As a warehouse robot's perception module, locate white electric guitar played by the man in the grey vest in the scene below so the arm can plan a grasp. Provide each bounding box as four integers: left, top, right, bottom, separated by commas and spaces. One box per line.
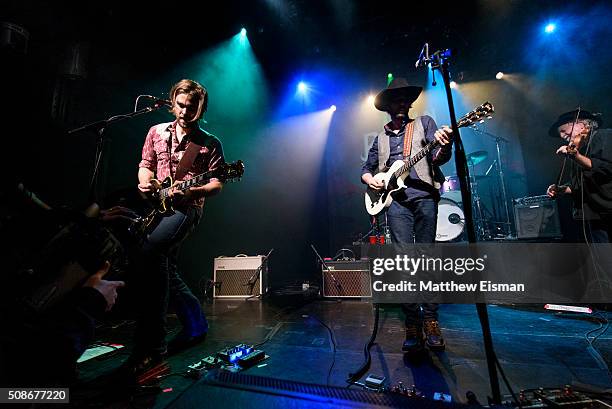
365, 102, 495, 216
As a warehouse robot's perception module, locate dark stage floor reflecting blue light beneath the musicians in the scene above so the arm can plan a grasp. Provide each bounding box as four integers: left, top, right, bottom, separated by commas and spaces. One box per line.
72, 299, 612, 408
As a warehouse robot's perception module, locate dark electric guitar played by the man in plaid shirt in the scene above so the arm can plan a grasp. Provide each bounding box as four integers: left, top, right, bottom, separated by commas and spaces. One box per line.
142, 160, 244, 227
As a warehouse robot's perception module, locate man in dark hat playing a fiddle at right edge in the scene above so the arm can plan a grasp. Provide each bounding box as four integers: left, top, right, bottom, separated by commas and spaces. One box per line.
546, 110, 612, 243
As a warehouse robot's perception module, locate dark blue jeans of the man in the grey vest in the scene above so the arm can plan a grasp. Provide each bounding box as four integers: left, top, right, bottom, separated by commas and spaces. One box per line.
387, 198, 438, 326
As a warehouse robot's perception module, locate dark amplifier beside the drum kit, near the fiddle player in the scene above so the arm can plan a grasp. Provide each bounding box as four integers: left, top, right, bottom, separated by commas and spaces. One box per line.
514, 196, 562, 239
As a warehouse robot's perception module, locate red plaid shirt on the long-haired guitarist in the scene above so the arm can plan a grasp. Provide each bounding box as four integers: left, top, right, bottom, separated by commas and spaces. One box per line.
138, 122, 225, 207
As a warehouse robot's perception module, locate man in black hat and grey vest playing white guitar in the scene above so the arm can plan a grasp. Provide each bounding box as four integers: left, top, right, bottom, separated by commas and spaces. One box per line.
361, 78, 452, 352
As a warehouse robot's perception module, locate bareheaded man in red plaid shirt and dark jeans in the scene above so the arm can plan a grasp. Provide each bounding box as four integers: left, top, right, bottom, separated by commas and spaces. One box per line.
121, 79, 224, 375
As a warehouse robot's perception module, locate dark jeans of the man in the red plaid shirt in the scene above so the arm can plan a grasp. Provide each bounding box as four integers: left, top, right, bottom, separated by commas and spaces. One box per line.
135, 207, 208, 352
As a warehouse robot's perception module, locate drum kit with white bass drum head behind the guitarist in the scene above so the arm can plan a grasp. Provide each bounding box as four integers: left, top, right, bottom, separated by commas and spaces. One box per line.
436, 151, 510, 242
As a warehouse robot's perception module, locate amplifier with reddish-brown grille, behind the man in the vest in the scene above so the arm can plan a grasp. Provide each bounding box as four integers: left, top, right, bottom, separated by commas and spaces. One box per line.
321, 260, 372, 298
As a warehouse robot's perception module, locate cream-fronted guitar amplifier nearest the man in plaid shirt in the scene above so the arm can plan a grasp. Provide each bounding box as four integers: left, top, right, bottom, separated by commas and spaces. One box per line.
213, 256, 268, 298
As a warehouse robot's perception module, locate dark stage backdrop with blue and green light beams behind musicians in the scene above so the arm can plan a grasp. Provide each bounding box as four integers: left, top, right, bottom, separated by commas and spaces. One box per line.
0, 0, 612, 294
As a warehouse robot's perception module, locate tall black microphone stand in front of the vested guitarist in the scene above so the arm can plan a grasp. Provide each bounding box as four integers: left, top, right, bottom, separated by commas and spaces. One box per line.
424, 49, 501, 404
